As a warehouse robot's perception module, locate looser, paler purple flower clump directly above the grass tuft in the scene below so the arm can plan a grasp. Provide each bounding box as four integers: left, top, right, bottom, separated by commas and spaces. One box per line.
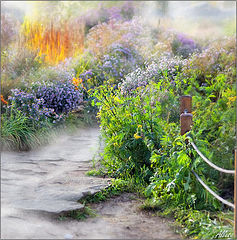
8, 89, 63, 126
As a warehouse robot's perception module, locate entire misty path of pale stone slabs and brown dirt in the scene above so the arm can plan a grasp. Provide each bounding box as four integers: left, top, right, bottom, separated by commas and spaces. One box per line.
1, 128, 180, 239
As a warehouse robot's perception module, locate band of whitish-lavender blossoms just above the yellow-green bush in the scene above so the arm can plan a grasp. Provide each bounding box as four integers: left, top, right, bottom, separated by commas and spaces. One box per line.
120, 55, 187, 93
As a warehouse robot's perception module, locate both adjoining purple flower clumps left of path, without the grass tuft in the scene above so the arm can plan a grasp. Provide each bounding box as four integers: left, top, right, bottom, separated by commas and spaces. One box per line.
8, 80, 83, 126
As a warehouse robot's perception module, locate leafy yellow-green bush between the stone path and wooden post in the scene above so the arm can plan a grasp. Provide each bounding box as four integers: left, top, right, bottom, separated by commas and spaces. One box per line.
92, 81, 177, 182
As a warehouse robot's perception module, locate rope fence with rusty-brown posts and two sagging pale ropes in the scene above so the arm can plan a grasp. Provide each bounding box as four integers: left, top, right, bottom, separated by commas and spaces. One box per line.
180, 96, 237, 238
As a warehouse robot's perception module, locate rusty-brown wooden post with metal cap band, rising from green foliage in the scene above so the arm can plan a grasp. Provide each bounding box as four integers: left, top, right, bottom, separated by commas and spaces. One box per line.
180, 96, 193, 135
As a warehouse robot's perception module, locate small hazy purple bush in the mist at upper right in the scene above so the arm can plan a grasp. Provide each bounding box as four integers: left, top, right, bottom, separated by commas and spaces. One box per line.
171, 34, 201, 58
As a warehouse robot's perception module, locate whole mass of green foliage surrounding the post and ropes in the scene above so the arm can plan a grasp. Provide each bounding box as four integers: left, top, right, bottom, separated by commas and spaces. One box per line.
90, 37, 236, 238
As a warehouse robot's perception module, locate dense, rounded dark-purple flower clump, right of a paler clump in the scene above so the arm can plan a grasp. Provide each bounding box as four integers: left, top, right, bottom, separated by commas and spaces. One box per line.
33, 80, 83, 114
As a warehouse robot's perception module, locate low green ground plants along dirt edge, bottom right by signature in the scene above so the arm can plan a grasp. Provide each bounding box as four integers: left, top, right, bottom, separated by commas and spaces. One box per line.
140, 198, 233, 239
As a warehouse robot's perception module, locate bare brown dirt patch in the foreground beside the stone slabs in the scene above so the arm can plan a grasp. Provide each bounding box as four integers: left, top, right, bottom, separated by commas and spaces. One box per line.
80, 193, 180, 239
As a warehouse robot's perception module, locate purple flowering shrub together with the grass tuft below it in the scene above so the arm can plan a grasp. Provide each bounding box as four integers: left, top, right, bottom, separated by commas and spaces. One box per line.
1, 69, 83, 150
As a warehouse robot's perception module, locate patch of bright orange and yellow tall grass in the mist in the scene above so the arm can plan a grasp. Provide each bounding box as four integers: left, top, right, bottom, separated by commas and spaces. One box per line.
21, 18, 84, 64
